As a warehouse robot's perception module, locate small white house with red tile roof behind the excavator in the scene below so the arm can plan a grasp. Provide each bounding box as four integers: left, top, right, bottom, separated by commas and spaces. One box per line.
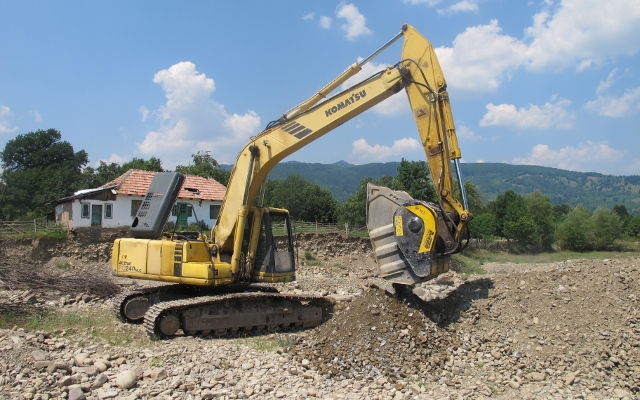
55, 169, 226, 229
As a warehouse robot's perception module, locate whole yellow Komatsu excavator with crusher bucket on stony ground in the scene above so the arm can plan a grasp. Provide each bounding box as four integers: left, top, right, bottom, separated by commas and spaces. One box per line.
112, 25, 472, 338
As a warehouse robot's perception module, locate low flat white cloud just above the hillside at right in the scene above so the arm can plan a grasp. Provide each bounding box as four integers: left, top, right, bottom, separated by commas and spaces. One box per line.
512, 141, 624, 171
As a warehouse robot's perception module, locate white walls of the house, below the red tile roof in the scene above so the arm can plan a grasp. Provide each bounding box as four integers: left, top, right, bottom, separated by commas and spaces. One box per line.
56, 195, 222, 229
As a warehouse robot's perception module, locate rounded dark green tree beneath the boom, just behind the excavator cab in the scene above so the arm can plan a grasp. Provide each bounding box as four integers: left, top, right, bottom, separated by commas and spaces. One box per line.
264, 175, 337, 222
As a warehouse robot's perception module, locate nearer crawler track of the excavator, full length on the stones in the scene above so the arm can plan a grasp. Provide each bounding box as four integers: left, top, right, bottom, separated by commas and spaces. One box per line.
144, 293, 333, 339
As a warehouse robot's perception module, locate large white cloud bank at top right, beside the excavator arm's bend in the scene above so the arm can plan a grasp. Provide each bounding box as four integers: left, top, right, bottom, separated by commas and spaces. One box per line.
430, 0, 640, 92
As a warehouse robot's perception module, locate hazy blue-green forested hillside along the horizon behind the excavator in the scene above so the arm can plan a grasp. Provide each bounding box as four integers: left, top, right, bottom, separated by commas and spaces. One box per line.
226, 161, 640, 214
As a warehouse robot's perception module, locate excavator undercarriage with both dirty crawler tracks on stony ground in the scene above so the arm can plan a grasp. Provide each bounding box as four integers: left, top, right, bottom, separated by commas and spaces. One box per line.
113, 284, 333, 339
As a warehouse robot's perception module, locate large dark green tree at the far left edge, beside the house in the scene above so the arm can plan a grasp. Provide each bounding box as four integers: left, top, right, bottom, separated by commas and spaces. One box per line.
0, 129, 88, 219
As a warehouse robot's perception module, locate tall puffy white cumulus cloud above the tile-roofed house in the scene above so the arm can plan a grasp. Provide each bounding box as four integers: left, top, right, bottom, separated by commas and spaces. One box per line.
138, 61, 260, 168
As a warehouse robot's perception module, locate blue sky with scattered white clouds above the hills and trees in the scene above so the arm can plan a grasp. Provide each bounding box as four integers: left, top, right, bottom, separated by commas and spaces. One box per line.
0, 0, 640, 175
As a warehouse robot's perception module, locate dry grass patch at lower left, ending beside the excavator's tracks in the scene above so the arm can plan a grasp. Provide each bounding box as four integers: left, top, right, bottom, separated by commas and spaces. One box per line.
0, 309, 151, 346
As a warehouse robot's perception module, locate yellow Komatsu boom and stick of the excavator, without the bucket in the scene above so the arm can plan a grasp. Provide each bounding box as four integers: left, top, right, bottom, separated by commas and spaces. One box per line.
212, 25, 471, 255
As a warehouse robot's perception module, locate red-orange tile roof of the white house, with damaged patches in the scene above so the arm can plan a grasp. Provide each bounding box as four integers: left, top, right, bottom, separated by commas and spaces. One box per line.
101, 169, 227, 200
